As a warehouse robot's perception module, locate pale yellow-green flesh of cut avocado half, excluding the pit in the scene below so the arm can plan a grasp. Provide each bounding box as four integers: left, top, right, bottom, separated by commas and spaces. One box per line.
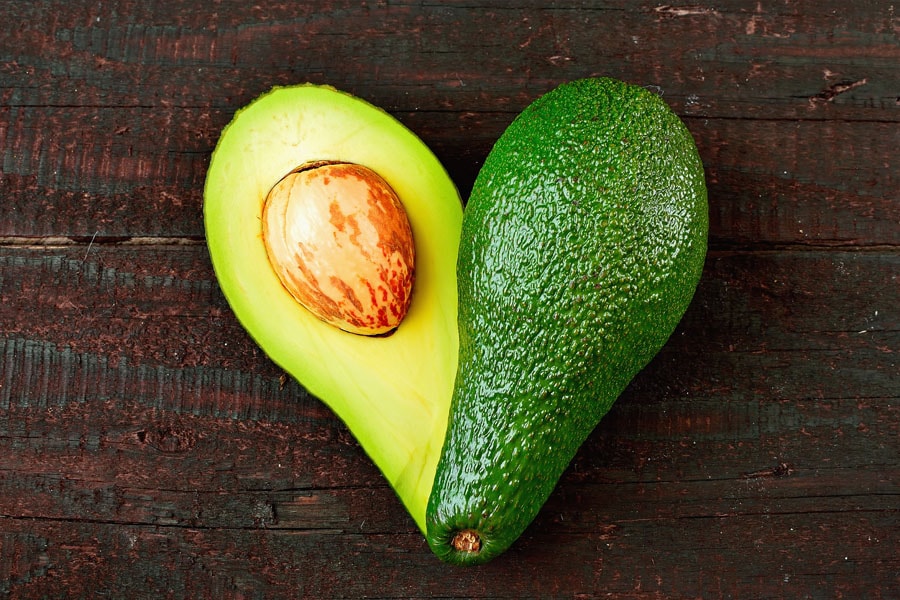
203, 84, 462, 531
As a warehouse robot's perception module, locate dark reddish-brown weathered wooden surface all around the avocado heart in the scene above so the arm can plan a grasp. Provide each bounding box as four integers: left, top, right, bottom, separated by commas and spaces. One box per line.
0, 0, 900, 599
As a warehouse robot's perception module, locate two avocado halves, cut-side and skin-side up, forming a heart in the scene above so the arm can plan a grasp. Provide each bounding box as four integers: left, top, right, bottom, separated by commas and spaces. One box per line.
204, 78, 708, 564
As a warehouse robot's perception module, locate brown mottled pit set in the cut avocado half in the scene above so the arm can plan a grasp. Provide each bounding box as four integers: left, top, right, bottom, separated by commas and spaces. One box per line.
262, 161, 415, 336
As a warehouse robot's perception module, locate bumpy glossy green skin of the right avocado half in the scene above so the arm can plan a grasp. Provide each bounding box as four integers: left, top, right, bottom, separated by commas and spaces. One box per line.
426, 79, 708, 564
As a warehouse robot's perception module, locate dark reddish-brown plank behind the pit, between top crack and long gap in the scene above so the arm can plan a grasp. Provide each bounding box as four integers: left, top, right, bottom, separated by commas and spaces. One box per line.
0, 108, 900, 247
